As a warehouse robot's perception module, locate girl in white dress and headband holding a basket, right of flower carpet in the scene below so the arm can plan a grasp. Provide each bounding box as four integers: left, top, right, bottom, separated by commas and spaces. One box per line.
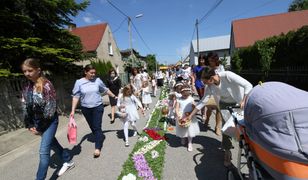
175, 85, 200, 151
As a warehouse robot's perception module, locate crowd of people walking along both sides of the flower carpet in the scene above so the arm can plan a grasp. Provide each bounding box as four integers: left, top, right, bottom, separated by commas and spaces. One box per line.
22, 53, 252, 179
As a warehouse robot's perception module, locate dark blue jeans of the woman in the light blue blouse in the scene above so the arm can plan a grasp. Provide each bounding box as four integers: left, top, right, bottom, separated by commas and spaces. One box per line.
81, 104, 104, 149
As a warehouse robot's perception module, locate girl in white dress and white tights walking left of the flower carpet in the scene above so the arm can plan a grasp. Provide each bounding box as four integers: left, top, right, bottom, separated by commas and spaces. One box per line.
117, 86, 144, 147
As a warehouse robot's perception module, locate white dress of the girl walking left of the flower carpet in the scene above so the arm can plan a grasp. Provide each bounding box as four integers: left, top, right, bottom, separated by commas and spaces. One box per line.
117, 93, 142, 122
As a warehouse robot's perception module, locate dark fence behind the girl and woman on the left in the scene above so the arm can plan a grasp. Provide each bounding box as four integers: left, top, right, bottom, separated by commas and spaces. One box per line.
0, 73, 129, 135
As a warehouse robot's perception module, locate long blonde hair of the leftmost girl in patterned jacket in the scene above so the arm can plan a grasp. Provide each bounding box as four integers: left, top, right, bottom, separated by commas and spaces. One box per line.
22, 58, 46, 93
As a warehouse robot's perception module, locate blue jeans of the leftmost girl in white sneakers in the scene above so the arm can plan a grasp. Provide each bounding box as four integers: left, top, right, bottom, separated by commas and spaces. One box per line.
36, 116, 71, 180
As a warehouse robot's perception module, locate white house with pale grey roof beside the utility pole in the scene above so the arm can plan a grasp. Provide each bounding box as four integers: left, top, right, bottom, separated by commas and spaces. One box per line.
189, 35, 230, 65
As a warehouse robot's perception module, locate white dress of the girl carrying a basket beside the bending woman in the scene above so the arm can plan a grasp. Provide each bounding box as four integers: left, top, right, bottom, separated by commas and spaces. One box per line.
176, 96, 200, 138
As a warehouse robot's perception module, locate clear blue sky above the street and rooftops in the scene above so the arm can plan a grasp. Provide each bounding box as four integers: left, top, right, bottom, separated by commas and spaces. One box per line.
72, 0, 292, 64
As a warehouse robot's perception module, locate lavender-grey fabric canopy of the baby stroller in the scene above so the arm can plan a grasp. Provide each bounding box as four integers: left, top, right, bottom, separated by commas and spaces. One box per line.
244, 82, 308, 163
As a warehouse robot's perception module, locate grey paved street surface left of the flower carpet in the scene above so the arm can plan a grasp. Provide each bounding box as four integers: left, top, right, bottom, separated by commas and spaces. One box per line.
0, 93, 158, 180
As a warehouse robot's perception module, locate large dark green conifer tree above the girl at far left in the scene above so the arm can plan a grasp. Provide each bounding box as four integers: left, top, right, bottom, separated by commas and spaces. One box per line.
0, 0, 89, 75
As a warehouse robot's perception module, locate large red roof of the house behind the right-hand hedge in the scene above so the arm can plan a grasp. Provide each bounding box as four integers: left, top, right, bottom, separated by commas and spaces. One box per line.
230, 10, 308, 54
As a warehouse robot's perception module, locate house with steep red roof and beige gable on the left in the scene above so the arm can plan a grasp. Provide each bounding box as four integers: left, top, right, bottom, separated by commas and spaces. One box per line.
69, 23, 124, 73
